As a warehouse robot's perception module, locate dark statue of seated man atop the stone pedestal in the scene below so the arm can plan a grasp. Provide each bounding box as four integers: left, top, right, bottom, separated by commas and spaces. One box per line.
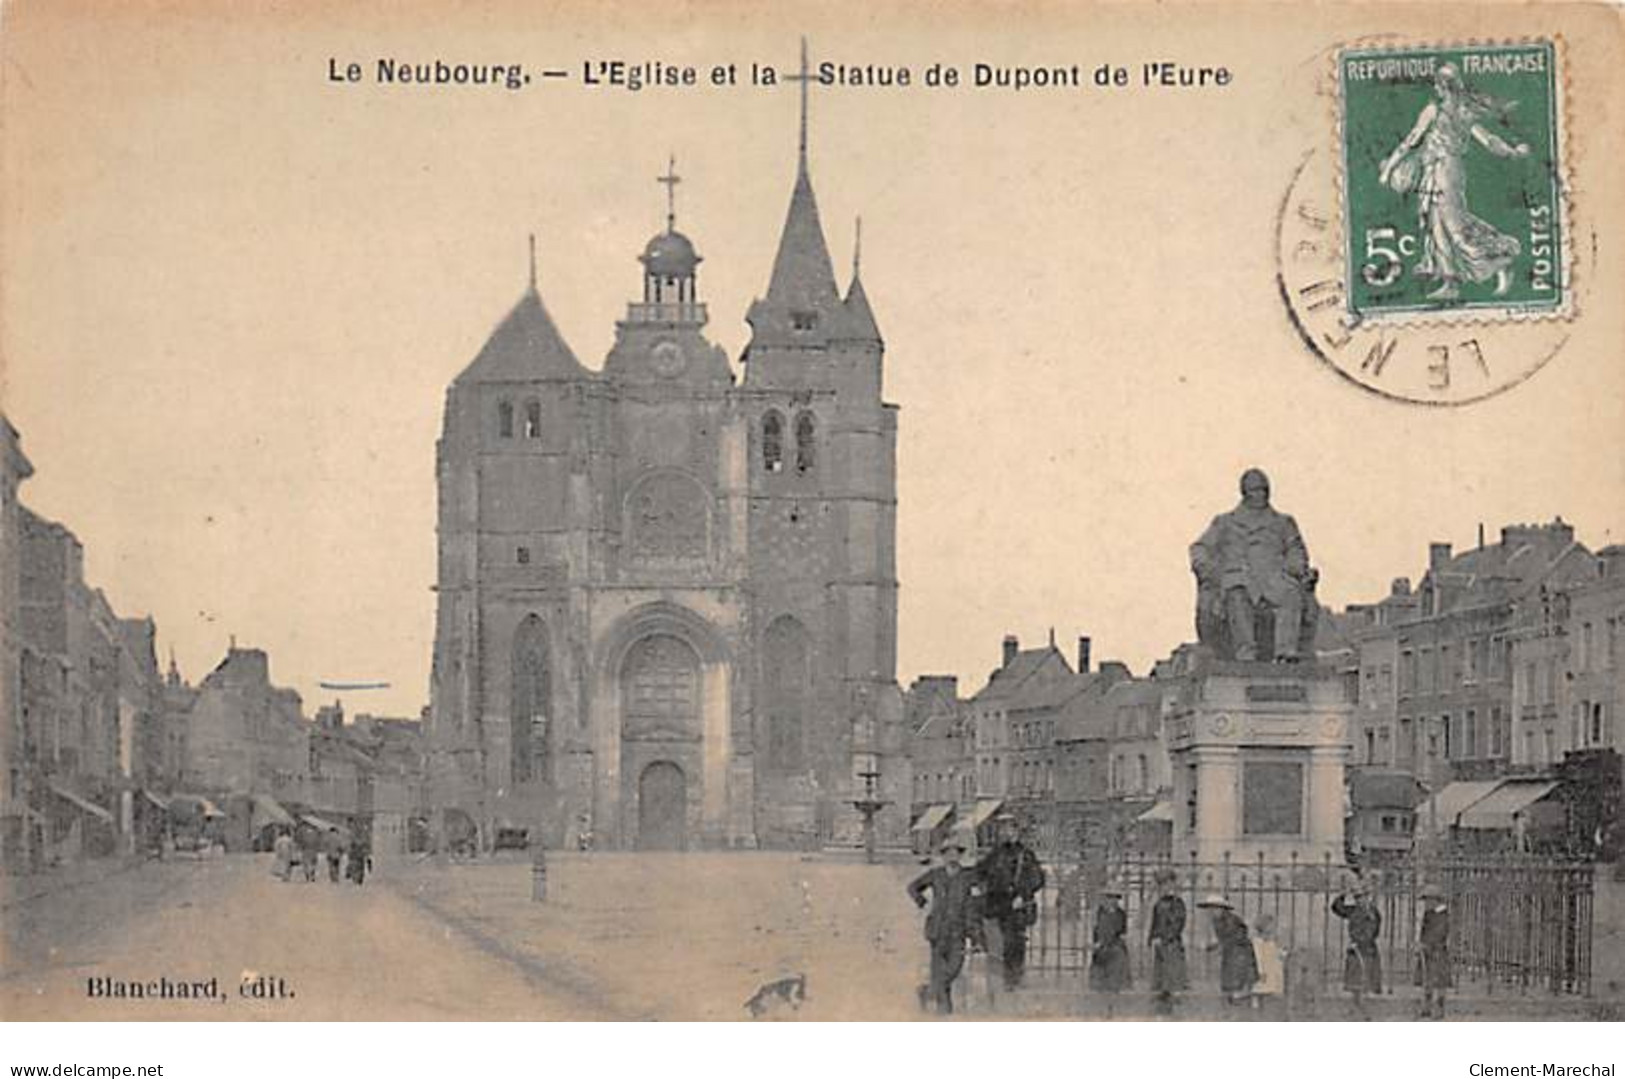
1191, 468, 1320, 661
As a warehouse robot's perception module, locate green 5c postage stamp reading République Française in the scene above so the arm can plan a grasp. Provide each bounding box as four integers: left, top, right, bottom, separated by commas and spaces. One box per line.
1337, 41, 1570, 322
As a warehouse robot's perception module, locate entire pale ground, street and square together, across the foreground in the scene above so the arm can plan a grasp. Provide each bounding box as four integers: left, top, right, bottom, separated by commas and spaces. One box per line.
0, 852, 1622, 1021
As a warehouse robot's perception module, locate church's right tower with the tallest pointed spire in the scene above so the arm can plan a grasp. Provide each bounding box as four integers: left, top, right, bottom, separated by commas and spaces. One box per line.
739, 42, 908, 845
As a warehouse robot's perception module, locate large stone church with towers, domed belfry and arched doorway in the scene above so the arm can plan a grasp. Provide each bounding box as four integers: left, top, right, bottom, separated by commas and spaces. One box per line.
429, 81, 908, 850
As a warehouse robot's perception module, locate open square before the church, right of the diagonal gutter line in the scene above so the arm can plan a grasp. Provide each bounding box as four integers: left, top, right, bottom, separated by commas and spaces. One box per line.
380, 852, 1622, 1022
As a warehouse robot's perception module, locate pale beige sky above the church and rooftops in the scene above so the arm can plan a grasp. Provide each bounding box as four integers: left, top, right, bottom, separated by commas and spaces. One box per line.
0, 3, 1625, 715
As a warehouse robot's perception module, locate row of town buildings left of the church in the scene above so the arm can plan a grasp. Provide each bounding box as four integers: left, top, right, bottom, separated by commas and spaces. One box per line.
0, 418, 427, 873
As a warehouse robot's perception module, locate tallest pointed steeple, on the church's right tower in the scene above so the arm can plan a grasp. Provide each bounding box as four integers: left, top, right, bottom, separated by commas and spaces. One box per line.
748, 39, 840, 333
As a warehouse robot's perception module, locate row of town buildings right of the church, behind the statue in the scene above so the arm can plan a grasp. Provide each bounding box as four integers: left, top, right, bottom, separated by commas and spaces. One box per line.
905, 520, 1625, 853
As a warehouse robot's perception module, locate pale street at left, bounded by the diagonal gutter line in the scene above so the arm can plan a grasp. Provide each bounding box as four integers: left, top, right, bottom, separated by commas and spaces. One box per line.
0, 856, 609, 1021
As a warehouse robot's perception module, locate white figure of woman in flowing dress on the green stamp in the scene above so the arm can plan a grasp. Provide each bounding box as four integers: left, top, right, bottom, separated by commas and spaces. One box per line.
1376, 63, 1529, 299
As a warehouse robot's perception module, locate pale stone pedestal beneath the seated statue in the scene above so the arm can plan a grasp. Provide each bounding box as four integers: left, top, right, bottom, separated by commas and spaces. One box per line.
1165, 660, 1354, 863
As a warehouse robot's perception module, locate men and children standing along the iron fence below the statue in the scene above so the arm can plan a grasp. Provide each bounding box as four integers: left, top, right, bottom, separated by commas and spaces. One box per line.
908, 819, 1451, 1019
